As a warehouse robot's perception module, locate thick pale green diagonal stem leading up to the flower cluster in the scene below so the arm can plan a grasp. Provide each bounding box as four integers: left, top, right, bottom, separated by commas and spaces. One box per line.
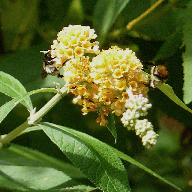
0, 88, 66, 145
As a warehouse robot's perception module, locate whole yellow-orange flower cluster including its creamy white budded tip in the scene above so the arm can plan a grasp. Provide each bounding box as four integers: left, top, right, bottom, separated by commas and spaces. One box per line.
45, 25, 158, 147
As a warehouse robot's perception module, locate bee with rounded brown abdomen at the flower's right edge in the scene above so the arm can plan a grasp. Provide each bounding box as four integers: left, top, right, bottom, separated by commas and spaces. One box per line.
150, 65, 168, 88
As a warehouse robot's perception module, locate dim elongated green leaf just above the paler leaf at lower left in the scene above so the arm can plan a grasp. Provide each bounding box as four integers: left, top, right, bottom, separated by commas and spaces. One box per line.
0, 144, 85, 178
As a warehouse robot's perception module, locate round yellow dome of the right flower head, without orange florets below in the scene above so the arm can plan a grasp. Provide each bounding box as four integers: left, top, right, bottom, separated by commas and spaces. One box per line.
91, 46, 147, 92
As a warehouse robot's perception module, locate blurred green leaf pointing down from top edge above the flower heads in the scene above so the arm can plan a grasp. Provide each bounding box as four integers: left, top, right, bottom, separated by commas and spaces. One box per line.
93, 0, 129, 43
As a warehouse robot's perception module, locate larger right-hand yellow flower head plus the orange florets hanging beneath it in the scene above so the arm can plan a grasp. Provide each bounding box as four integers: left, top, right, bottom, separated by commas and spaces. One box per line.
90, 46, 148, 119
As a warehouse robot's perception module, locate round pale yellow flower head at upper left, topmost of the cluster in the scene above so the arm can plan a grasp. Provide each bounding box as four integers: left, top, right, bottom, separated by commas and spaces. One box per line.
51, 25, 99, 69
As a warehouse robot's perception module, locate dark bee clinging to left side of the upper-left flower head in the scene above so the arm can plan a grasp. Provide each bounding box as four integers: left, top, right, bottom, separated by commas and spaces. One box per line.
41, 50, 59, 78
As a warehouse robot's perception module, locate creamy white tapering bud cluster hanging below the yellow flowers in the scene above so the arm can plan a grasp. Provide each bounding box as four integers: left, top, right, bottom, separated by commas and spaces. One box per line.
121, 88, 158, 148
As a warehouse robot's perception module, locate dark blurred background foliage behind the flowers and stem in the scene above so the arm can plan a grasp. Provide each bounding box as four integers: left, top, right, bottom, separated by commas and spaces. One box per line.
0, 0, 192, 192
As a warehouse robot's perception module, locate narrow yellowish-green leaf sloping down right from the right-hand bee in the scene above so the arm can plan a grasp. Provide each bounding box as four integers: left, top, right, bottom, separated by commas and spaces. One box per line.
158, 83, 192, 113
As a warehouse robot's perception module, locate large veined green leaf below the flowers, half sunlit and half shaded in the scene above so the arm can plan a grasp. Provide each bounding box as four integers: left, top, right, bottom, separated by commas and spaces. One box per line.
39, 123, 130, 192
